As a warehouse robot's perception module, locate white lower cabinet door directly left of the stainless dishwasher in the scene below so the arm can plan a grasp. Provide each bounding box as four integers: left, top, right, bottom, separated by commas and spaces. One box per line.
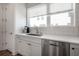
31, 43, 41, 56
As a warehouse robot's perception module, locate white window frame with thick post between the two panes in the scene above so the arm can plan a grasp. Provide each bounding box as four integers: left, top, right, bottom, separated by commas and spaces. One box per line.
26, 3, 76, 27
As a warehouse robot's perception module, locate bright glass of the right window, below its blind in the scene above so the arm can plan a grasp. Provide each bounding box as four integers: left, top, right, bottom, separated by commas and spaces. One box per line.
50, 12, 71, 26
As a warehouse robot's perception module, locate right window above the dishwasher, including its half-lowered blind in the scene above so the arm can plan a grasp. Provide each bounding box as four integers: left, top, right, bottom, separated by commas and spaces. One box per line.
49, 3, 74, 26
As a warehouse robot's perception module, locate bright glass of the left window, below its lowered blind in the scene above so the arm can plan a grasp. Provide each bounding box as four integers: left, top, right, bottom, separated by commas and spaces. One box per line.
29, 16, 47, 27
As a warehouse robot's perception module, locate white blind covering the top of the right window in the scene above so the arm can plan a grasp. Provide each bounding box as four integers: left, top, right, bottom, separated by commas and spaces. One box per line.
49, 3, 73, 13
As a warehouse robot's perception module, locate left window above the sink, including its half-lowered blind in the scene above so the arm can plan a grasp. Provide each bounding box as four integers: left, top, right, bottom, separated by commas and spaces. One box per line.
27, 4, 47, 27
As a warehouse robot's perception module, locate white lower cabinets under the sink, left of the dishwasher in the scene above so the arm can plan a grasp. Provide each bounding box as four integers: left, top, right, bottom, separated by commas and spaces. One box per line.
16, 38, 41, 56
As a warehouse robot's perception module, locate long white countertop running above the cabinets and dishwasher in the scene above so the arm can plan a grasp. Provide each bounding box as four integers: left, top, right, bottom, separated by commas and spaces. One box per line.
16, 33, 79, 44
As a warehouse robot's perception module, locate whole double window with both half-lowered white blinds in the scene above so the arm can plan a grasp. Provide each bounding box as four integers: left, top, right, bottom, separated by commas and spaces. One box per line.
27, 3, 74, 27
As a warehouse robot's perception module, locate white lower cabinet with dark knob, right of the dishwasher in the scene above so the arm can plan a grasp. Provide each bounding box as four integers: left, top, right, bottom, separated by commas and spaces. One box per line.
70, 44, 79, 56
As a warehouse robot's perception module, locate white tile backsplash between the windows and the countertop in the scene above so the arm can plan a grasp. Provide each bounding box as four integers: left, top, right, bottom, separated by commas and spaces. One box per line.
31, 26, 79, 36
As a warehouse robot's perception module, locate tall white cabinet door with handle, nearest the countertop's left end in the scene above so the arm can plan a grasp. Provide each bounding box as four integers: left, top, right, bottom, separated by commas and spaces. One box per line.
5, 4, 15, 53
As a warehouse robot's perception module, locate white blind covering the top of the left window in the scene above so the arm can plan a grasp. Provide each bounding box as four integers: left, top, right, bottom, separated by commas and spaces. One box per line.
27, 4, 47, 18
